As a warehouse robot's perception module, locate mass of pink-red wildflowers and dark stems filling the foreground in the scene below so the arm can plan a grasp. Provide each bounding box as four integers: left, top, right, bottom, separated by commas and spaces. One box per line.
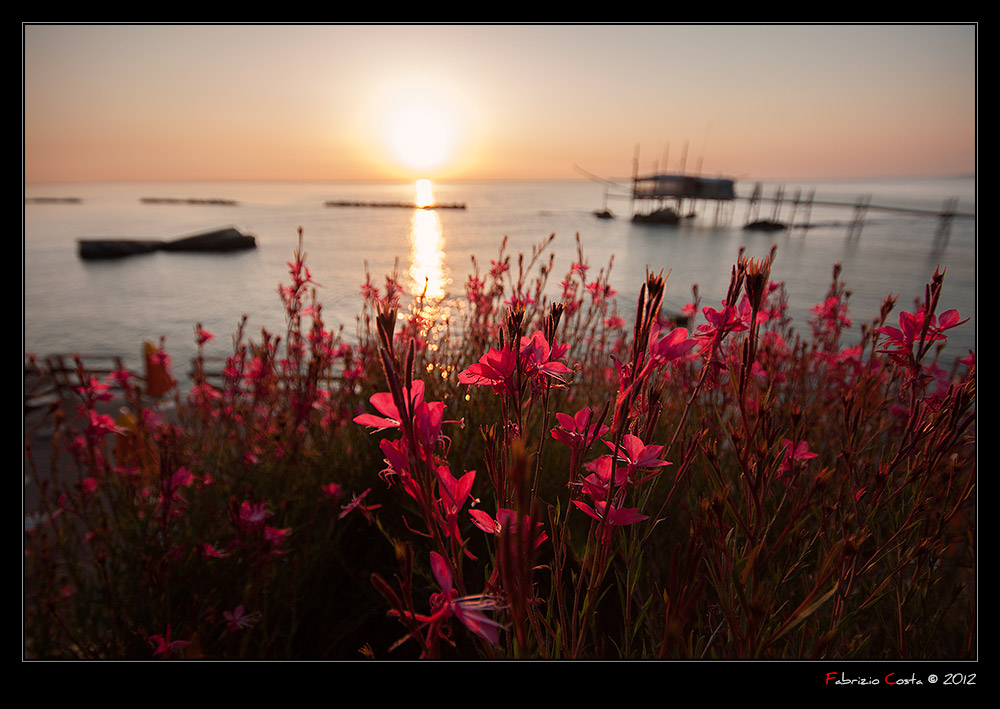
24, 231, 976, 659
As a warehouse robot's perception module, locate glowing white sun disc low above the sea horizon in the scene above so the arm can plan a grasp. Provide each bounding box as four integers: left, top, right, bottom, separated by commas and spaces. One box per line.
383, 89, 459, 171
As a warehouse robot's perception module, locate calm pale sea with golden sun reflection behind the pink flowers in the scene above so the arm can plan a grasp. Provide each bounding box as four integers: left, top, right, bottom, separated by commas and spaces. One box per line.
22, 177, 977, 373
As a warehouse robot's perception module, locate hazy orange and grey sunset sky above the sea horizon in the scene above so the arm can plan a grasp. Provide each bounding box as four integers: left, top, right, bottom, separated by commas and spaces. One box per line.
23, 24, 977, 182
